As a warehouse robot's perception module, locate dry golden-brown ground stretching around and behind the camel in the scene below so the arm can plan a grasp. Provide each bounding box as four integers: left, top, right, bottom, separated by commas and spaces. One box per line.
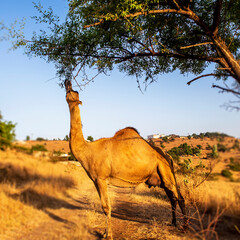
0, 137, 240, 240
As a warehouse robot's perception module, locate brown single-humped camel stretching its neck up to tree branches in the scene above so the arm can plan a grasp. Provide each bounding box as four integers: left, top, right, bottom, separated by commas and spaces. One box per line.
65, 81, 186, 239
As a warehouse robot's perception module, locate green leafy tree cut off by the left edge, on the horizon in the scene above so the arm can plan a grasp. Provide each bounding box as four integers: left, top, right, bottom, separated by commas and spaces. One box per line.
0, 114, 16, 150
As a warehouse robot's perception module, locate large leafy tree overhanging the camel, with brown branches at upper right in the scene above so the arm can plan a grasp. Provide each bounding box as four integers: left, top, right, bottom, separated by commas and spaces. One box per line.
3, 0, 240, 110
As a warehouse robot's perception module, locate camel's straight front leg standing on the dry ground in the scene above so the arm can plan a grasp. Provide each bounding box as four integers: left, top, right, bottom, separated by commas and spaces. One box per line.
95, 179, 113, 240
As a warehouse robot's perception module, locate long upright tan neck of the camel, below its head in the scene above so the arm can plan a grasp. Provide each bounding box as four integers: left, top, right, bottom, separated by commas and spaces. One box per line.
69, 102, 86, 154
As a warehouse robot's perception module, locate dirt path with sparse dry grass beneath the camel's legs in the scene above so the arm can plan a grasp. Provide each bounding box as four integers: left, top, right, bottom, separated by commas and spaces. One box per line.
15, 183, 188, 240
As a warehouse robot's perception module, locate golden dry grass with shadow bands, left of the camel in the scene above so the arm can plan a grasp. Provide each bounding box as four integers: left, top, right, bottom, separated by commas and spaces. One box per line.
0, 151, 93, 239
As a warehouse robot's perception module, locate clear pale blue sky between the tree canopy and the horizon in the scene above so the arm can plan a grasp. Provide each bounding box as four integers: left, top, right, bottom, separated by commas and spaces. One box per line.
0, 0, 240, 140
